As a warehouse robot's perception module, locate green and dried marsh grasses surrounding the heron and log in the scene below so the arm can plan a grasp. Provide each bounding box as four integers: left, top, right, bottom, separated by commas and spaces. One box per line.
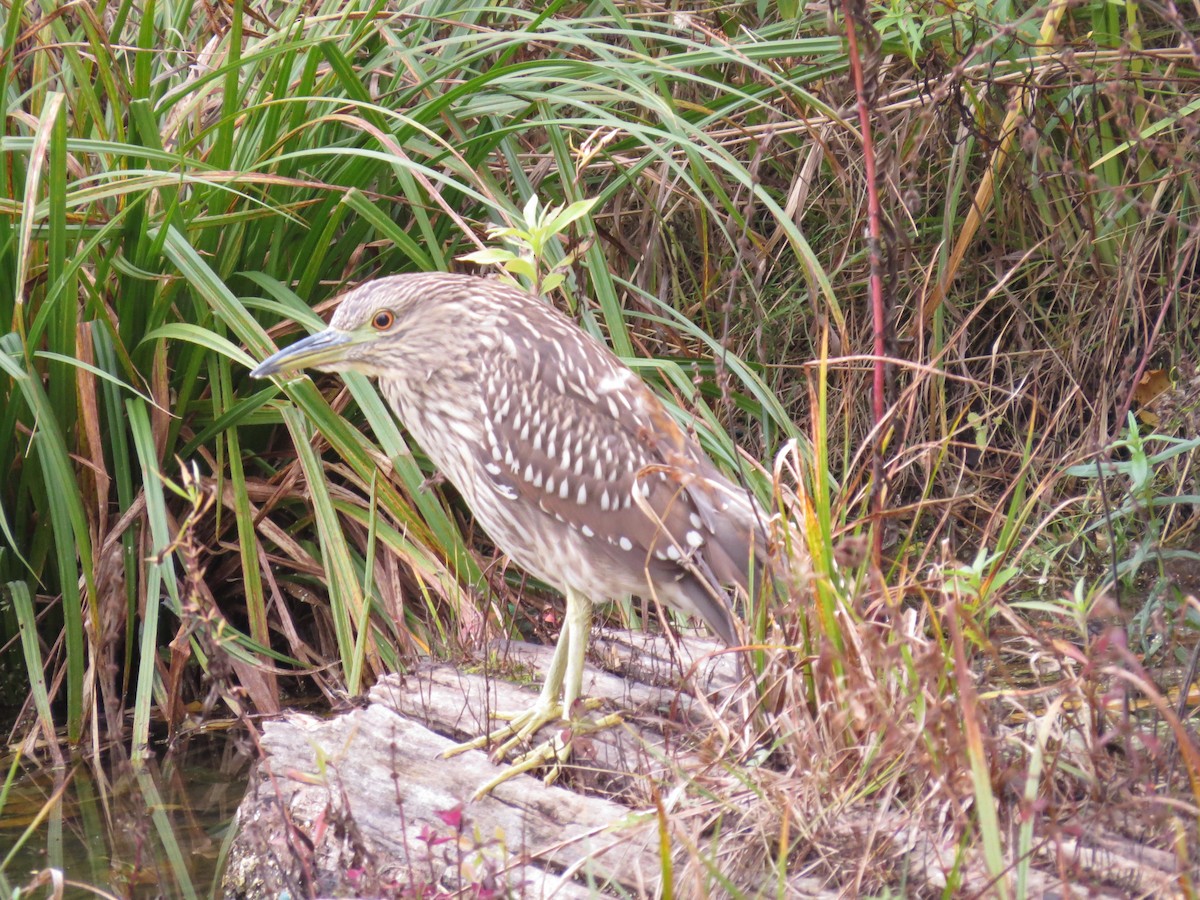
0, 0, 1200, 896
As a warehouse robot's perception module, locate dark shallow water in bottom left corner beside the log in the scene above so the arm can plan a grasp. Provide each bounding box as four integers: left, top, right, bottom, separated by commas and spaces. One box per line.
0, 726, 251, 900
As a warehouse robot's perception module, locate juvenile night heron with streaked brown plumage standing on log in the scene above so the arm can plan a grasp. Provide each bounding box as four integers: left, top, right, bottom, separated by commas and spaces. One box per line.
252, 274, 764, 791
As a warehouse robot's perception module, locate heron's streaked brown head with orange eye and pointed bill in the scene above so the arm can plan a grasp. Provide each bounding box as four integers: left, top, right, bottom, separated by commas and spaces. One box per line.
251, 274, 487, 378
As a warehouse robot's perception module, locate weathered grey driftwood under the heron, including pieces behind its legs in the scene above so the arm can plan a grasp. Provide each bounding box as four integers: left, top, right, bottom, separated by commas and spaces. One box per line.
224, 637, 777, 898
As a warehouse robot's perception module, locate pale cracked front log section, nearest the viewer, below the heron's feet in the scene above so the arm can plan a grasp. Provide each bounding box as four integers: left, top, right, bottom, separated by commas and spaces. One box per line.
226, 703, 660, 898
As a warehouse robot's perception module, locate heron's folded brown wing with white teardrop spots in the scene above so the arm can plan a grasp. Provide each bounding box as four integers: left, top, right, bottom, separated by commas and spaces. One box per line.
480, 320, 761, 642
